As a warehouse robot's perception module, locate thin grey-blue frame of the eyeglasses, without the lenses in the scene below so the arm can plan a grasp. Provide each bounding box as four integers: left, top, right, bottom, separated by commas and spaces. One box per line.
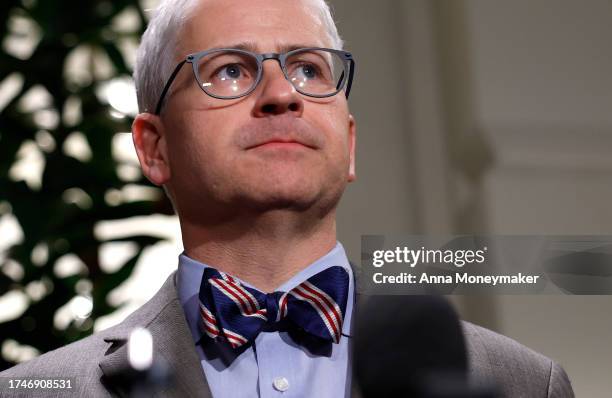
155, 47, 355, 115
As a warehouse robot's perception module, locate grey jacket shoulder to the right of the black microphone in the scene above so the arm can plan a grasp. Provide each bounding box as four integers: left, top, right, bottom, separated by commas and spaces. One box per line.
462, 321, 574, 398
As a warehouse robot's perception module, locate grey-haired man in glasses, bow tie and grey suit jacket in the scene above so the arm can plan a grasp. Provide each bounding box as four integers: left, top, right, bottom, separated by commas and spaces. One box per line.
3, 0, 572, 397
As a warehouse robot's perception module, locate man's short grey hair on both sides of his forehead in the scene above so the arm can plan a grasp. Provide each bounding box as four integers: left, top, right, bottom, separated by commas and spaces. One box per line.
134, 0, 344, 113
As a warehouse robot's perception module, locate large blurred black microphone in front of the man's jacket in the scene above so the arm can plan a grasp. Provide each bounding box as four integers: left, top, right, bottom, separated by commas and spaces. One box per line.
354, 296, 495, 398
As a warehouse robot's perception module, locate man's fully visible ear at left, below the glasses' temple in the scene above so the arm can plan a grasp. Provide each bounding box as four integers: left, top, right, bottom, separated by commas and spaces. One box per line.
132, 113, 170, 185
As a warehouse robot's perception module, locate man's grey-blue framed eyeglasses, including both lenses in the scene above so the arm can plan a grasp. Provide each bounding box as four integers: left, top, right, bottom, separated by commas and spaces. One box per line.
155, 47, 355, 115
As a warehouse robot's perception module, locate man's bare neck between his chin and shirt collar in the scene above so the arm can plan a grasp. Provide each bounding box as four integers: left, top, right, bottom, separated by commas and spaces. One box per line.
181, 210, 336, 292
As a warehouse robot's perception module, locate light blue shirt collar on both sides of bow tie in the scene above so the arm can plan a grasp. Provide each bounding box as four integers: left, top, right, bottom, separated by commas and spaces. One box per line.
177, 242, 355, 341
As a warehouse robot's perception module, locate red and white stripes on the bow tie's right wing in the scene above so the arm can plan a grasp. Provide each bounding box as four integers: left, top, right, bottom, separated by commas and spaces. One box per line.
288, 281, 342, 343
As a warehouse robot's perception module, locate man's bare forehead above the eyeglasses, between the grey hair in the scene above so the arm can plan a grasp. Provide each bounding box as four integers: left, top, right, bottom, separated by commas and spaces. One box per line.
179, 0, 331, 55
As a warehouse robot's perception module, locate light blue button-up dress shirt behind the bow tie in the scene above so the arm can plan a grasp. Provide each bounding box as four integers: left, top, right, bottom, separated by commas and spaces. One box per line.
177, 243, 355, 398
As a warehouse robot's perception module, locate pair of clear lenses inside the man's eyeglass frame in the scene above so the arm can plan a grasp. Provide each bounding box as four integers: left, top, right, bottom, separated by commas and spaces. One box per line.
196, 50, 346, 98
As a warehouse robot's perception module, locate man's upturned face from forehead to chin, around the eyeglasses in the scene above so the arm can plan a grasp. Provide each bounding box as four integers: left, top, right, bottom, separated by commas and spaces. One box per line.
154, 0, 355, 217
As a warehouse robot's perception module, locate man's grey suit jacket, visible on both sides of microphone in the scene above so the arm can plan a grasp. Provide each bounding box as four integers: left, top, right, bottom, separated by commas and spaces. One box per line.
0, 273, 574, 398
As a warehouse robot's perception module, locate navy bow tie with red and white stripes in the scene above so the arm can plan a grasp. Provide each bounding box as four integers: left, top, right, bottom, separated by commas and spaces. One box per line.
199, 266, 349, 349
